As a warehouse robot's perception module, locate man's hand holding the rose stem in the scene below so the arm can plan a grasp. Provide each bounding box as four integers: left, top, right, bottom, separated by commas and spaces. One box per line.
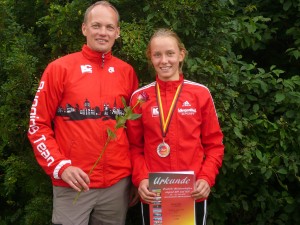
61, 166, 90, 192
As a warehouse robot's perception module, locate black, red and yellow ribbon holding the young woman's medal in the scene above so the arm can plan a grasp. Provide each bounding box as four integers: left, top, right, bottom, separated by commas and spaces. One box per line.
156, 82, 183, 137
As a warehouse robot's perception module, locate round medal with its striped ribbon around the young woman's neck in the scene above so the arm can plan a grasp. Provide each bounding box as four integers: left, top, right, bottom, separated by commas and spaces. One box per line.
156, 83, 182, 158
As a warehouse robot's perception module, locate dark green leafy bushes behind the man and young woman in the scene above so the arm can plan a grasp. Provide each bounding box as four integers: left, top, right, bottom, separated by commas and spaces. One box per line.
0, 0, 300, 225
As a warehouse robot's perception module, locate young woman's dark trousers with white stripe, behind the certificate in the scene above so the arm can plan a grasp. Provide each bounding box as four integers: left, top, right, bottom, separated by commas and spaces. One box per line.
141, 201, 207, 225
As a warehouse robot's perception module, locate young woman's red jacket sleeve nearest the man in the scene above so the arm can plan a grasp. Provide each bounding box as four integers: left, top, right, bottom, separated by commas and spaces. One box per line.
127, 93, 149, 187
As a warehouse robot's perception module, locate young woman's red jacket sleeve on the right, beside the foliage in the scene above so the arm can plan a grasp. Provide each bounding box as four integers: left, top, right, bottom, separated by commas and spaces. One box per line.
197, 90, 224, 187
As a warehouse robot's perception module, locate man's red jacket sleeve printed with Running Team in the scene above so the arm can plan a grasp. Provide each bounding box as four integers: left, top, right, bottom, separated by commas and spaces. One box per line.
27, 63, 71, 179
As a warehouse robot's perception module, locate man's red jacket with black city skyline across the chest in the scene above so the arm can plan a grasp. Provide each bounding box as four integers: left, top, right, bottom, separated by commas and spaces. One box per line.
28, 45, 138, 188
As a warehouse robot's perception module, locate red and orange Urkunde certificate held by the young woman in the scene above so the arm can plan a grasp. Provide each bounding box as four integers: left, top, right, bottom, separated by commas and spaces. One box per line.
149, 171, 196, 225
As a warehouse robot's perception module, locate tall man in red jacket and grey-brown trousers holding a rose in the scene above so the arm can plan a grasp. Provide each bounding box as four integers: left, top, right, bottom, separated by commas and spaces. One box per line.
28, 1, 138, 225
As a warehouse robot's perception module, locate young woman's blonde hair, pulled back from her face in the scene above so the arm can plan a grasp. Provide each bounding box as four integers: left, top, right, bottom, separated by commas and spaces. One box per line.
146, 28, 187, 72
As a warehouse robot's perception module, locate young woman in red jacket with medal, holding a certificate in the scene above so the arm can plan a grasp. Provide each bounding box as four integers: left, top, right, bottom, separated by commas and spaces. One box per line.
127, 29, 224, 225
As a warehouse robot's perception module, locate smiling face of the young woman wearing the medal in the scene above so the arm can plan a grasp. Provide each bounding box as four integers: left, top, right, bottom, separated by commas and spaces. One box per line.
150, 36, 185, 81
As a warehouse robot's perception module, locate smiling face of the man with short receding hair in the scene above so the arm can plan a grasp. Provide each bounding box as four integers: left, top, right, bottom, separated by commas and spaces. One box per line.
82, 5, 120, 53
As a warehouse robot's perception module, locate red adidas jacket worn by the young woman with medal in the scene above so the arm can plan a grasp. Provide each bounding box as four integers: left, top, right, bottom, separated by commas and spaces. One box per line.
127, 75, 224, 192
